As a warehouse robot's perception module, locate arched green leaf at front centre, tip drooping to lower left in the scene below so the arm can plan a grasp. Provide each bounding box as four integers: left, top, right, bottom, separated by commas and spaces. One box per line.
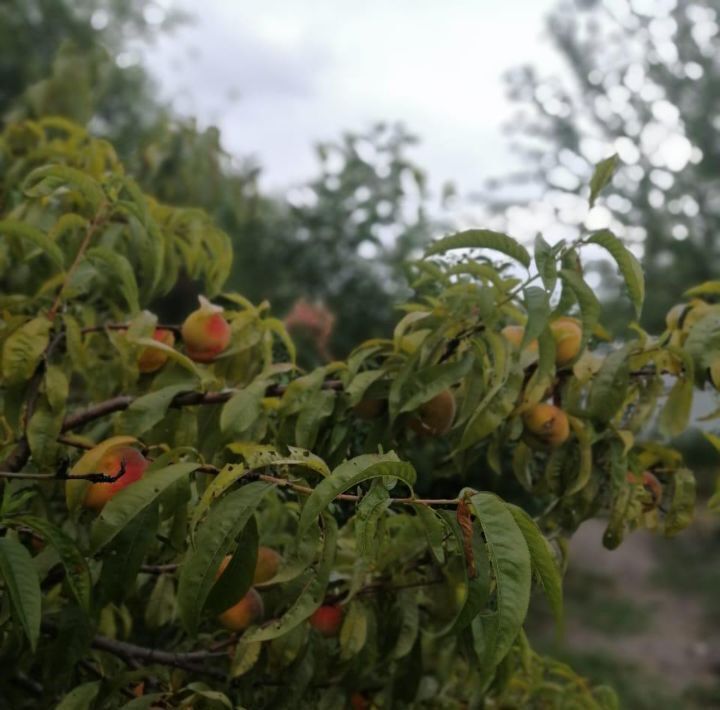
298, 452, 416, 535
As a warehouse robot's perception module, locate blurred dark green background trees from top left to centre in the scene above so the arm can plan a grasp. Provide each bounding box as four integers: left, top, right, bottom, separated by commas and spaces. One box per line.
0, 0, 433, 358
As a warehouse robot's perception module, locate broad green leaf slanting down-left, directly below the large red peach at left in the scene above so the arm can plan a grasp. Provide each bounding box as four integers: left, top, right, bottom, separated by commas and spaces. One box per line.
90, 463, 200, 552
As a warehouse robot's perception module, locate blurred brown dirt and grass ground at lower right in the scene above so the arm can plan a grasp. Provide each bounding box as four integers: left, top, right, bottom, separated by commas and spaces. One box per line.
530, 515, 720, 710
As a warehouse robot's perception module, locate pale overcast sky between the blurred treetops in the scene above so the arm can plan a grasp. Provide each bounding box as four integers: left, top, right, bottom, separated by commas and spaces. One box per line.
145, 0, 562, 192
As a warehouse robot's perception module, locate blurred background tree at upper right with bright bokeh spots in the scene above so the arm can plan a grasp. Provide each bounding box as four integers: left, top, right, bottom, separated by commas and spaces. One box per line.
485, 0, 720, 330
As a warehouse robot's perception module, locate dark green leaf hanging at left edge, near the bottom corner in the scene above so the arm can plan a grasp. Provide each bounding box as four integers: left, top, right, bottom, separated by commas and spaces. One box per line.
0, 537, 42, 651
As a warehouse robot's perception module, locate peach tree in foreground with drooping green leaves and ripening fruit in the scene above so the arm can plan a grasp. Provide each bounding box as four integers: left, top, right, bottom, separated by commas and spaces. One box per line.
0, 119, 720, 709
